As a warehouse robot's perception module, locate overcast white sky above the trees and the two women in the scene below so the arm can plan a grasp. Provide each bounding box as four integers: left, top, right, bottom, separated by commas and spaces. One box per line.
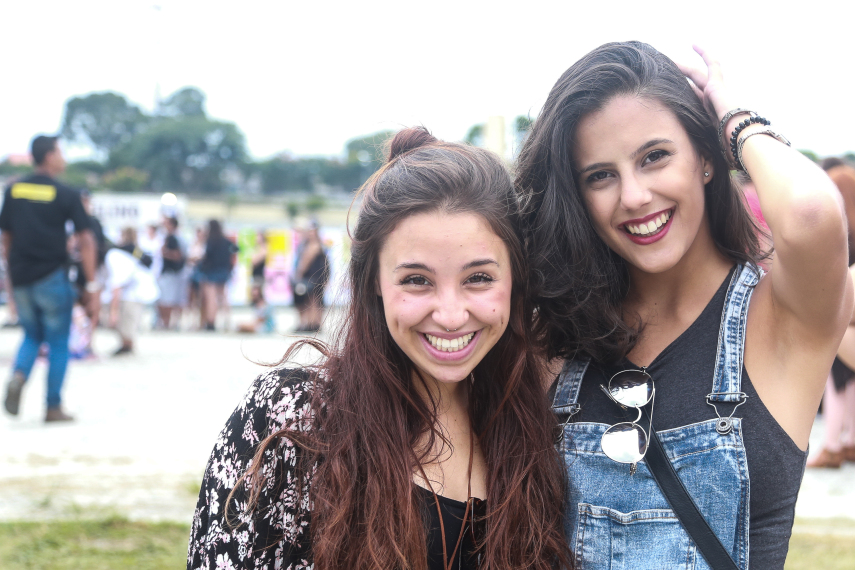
0, 0, 855, 158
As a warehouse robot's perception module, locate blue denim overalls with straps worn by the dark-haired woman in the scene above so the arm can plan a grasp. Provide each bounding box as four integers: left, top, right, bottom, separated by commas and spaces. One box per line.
553, 266, 759, 570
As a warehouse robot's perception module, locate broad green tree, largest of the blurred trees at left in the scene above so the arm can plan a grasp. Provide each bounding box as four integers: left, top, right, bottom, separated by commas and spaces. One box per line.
109, 116, 247, 194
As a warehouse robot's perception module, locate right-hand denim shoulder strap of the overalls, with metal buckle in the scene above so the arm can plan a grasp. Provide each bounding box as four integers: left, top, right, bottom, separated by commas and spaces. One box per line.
707, 265, 762, 403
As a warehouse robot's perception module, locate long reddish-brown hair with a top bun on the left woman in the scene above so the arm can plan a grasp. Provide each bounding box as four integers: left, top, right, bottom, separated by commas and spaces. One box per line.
231, 128, 570, 570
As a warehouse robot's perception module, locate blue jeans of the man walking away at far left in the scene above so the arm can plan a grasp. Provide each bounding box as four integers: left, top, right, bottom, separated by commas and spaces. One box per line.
12, 267, 74, 408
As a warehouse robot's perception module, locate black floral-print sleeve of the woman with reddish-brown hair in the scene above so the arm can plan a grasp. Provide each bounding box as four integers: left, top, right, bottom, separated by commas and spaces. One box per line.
187, 369, 313, 570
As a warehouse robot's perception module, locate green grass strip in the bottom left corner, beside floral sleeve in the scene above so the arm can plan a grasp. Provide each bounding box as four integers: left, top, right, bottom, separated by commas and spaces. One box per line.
0, 517, 190, 570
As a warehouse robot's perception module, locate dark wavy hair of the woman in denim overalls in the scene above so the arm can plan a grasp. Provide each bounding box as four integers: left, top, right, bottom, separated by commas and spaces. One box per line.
515, 42, 763, 361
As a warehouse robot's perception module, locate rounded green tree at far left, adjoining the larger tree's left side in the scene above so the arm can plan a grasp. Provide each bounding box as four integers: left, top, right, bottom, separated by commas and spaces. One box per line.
61, 91, 149, 155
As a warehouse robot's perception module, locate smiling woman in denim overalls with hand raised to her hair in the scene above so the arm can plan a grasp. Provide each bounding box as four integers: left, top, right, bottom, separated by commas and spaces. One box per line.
517, 42, 852, 570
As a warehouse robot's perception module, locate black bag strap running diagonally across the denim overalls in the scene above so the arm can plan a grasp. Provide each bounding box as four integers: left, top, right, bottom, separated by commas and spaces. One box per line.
644, 410, 739, 570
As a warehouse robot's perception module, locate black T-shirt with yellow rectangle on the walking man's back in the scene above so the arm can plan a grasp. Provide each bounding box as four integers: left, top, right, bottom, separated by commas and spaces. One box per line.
0, 174, 89, 286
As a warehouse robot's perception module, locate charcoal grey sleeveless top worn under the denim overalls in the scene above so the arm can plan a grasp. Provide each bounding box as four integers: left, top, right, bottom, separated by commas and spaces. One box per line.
551, 271, 807, 569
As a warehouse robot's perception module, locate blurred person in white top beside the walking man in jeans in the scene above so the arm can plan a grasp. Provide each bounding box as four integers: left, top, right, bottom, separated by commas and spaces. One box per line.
100, 233, 160, 356
